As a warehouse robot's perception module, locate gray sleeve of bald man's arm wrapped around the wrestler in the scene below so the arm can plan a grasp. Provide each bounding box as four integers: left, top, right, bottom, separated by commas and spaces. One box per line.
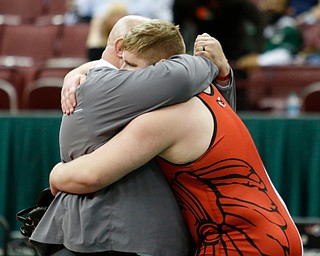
84, 54, 218, 112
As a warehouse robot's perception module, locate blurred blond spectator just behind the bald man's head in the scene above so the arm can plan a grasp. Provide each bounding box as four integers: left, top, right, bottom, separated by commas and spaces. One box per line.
87, 3, 128, 61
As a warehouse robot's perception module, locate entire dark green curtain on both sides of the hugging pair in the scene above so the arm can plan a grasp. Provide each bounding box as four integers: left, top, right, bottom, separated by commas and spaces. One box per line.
0, 113, 320, 230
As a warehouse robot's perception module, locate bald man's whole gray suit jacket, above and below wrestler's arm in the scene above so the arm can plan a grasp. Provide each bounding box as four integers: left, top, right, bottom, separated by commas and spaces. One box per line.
31, 55, 218, 256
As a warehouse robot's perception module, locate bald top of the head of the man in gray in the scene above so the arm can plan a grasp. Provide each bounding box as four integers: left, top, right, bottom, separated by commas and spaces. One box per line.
108, 15, 151, 45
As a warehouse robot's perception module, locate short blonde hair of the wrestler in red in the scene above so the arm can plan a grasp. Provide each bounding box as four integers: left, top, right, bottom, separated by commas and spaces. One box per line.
122, 20, 186, 65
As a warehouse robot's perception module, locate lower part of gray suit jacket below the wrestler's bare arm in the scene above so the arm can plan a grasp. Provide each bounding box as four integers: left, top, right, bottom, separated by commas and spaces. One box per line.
33, 162, 192, 256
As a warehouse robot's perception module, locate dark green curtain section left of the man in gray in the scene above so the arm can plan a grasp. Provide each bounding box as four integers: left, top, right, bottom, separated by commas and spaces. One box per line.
0, 115, 60, 230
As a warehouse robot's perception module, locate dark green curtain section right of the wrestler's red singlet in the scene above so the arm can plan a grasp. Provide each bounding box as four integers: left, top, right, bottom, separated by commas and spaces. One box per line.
242, 115, 320, 217
